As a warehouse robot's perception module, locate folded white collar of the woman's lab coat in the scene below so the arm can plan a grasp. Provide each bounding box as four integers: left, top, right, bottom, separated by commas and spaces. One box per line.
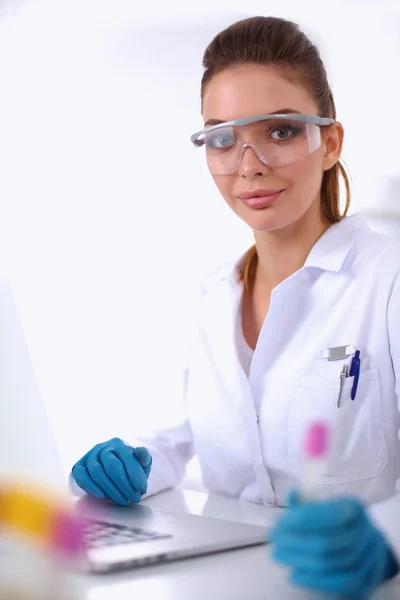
231, 213, 370, 284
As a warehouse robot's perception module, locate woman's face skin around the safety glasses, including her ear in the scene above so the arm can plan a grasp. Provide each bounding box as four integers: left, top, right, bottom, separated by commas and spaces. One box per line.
203, 64, 343, 231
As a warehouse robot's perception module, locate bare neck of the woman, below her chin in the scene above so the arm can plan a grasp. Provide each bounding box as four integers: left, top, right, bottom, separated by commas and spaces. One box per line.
254, 205, 330, 291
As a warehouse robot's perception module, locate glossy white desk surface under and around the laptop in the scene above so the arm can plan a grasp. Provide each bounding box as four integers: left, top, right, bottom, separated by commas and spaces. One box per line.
63, 489, 400, 600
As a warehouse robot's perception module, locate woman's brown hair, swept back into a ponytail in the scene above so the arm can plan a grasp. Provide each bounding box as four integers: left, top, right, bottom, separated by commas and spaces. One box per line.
201, 17, 350, 288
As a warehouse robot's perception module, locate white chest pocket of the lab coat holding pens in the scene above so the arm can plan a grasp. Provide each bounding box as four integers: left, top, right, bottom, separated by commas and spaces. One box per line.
287, 369, 388, 484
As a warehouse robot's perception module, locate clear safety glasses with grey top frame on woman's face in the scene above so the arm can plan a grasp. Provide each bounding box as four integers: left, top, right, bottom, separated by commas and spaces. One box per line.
190, 113, 335, 175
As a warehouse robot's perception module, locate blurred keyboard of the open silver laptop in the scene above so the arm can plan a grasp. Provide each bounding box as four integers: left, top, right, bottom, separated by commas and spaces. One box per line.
84, 520, 172, 548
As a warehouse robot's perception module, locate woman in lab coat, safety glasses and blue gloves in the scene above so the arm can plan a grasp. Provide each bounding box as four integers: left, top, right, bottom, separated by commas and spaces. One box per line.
73, 17, 400, 598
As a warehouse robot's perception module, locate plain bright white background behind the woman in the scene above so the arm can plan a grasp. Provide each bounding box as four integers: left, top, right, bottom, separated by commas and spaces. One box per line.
0, 0, 400, 478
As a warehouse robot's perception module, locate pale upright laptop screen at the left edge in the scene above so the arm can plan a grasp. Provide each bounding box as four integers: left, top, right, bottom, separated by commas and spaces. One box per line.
0, 279, 66, 487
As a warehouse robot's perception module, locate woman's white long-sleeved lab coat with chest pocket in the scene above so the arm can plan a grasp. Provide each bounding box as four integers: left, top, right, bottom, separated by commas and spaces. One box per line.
129, 215, 400, 558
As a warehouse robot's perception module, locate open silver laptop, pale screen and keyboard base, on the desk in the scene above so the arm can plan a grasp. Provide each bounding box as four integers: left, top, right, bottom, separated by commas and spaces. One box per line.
0, 279, 266, 573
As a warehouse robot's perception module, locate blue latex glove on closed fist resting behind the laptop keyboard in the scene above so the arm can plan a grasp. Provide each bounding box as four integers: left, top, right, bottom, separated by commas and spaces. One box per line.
72, 438, 152, 506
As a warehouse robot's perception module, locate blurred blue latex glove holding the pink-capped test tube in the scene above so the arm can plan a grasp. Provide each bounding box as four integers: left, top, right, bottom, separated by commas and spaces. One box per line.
269, 492, 399, 600
